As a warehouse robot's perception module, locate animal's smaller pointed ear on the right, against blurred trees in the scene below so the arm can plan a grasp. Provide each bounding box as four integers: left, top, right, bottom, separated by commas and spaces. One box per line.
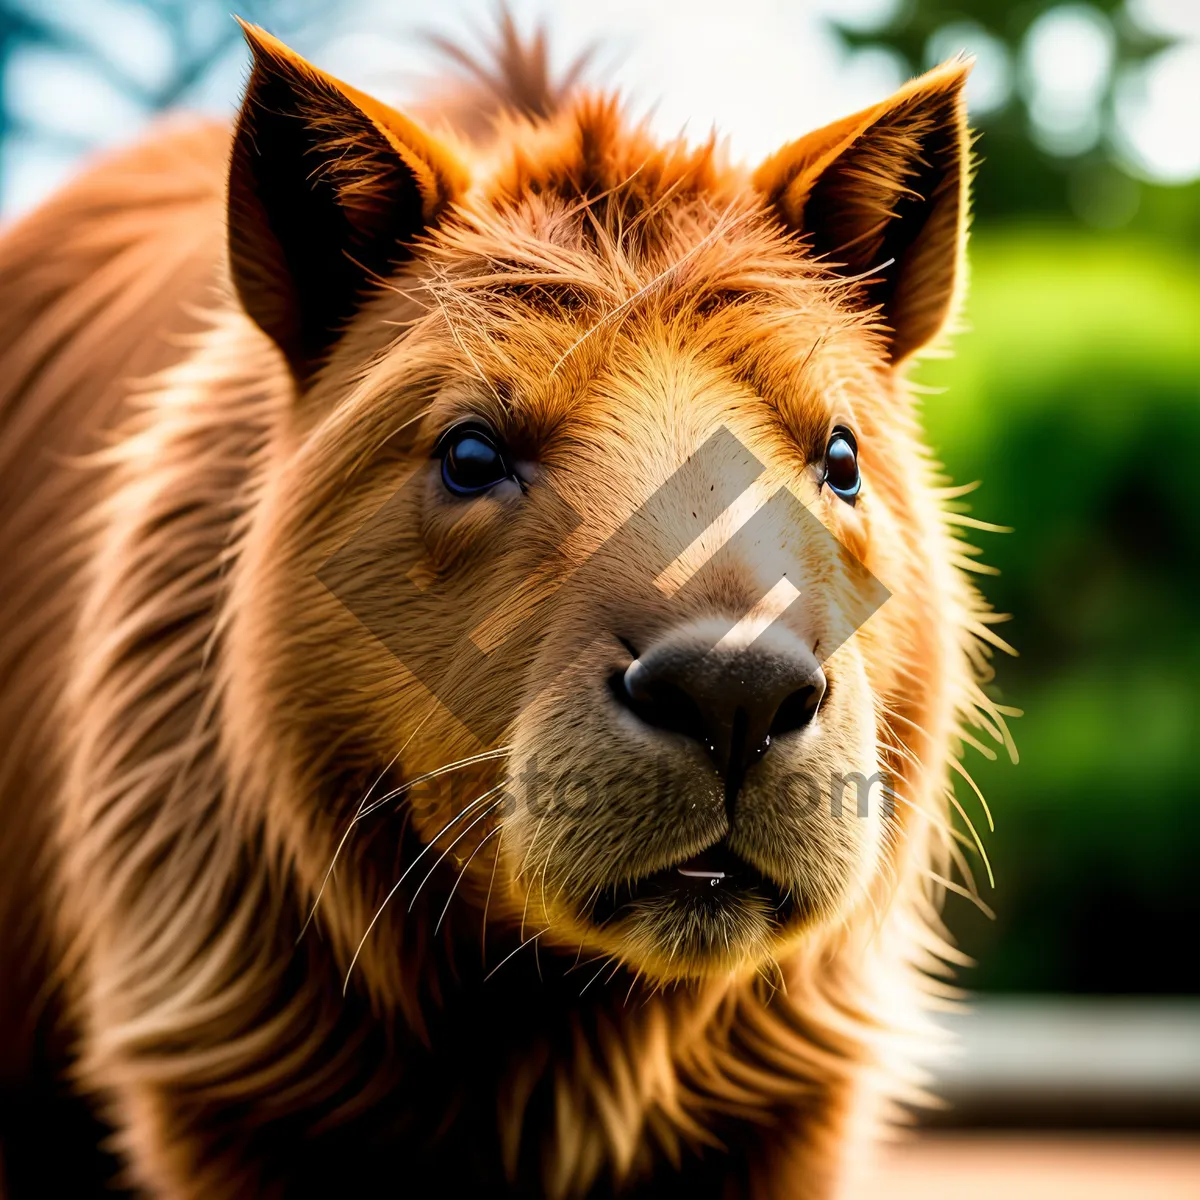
755, 61, 971, 362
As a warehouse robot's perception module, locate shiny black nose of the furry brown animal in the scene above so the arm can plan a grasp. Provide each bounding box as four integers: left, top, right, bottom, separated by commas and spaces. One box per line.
613, 623, 826, 794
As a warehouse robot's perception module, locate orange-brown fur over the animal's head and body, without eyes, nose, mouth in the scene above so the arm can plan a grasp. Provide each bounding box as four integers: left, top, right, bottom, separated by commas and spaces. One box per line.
0, 18, 1007, 1198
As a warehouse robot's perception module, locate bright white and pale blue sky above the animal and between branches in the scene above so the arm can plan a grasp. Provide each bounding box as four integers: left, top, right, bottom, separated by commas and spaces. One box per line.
0, 0, 1200, 216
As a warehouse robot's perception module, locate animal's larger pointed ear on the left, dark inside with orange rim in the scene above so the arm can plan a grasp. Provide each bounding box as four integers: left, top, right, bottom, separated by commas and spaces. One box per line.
229, 23, 467, 385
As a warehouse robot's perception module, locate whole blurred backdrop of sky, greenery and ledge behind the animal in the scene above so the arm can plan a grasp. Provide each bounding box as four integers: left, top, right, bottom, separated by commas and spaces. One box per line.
0, 0, 1200, 1200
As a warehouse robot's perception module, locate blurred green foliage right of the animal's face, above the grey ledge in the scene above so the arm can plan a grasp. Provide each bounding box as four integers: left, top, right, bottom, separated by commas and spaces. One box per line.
917, 226, 1200, 992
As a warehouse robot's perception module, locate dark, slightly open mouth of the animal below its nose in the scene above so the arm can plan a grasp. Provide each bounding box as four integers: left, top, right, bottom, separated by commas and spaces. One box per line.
589, 838, 797, 926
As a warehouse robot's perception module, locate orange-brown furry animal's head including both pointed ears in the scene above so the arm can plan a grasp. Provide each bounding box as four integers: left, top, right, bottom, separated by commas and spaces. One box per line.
223, 21, 973, 1000
